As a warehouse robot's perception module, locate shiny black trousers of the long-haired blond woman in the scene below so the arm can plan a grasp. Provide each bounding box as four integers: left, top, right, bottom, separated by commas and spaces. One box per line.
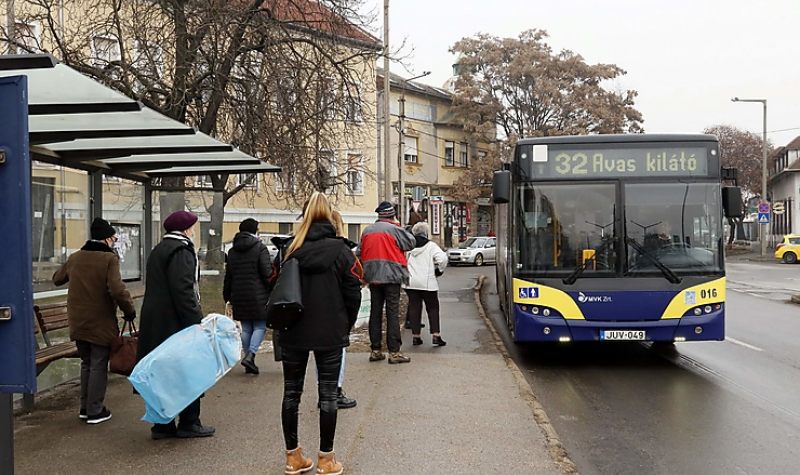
281, 348, 342, 452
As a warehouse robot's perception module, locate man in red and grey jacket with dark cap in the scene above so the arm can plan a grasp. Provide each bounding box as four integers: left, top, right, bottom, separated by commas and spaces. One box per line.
356, 201, 416, 364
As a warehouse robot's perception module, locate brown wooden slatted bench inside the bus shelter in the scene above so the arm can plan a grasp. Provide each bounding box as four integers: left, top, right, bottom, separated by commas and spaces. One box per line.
23, 285, 144, 411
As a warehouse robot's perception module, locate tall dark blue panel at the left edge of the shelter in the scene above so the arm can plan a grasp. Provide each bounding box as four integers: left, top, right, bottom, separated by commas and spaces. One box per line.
0, 76, 36, 393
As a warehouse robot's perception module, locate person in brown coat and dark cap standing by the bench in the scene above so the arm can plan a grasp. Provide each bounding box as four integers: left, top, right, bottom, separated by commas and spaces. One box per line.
53, 218, 136, 424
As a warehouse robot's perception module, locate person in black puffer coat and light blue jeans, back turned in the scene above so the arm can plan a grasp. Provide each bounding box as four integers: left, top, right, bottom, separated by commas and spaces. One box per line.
222, 218, 272, 374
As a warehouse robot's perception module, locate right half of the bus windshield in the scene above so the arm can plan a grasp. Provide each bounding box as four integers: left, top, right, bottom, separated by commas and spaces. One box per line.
625, 182, 722, 274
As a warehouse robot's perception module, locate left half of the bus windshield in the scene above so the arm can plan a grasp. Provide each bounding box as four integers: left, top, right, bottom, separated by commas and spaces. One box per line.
514, 183, 618, 276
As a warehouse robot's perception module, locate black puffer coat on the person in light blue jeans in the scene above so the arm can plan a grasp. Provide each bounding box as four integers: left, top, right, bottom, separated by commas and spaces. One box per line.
222, 233, 272, 320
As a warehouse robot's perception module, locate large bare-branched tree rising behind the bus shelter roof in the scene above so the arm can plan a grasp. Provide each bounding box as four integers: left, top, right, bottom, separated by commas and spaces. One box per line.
3, 0, 380, 265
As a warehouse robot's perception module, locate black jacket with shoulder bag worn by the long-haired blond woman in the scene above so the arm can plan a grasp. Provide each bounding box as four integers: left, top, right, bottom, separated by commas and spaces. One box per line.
279, 221, 362, 351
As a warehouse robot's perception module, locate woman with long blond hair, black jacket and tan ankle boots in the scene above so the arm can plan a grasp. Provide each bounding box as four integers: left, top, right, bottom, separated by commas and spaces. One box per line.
279, 192, 361, 474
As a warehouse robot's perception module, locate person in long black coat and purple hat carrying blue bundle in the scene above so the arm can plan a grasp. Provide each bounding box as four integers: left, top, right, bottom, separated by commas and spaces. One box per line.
138, 211, 214, 439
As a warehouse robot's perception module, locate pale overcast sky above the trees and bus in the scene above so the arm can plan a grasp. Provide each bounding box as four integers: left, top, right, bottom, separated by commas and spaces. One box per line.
366, 0, 800, 145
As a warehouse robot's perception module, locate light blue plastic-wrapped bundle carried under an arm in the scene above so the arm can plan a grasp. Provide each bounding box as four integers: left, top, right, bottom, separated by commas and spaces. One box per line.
128, 313, 242, 424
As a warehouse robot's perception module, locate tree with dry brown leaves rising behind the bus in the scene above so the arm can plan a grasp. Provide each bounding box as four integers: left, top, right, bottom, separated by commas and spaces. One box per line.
450, 30, 642, 203
